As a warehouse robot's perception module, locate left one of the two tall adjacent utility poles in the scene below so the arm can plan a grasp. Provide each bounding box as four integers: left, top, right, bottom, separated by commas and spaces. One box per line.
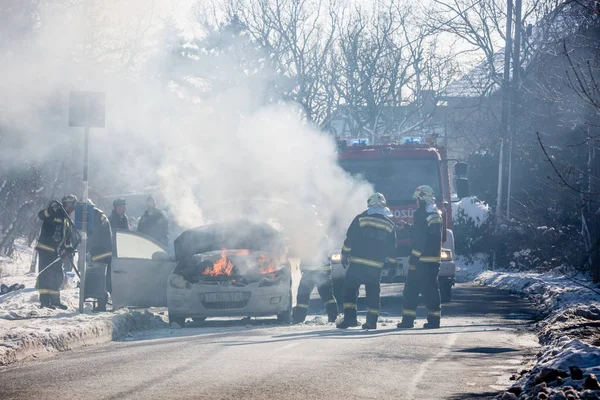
496, 0, 513, 223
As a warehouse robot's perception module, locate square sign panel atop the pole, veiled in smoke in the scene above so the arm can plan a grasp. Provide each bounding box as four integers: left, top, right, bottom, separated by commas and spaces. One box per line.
69, 90, 105, 128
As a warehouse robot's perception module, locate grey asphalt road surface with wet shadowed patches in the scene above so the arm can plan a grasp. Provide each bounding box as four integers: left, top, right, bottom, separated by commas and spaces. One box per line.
0, 285, 537, 400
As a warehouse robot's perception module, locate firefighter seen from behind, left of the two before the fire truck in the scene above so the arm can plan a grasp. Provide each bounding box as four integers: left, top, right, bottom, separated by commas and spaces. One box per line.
337, 193, 396, 329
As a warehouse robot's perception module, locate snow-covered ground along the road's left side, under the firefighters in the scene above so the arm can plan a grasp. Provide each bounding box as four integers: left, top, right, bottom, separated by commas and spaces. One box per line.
0, 244, 168, 366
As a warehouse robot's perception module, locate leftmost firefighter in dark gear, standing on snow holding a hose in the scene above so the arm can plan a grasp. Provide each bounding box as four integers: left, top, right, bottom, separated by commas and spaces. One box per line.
36, 194, 79, 310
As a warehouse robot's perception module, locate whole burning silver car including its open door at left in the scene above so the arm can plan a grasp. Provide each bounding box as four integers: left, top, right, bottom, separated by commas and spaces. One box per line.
111, 202, 308, 326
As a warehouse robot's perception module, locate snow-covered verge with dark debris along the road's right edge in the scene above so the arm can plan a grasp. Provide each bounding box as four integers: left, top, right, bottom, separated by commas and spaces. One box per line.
474, 271, 600, 399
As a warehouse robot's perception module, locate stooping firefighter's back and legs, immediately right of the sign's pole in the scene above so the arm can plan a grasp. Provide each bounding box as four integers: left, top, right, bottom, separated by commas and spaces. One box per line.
88, 200, 112, 312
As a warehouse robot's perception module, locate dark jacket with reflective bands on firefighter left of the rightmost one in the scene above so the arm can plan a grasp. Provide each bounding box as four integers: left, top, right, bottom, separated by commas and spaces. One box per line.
342, 211, 396, 268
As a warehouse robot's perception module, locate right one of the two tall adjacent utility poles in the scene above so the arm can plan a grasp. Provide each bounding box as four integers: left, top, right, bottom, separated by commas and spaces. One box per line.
506, 0, 522, 217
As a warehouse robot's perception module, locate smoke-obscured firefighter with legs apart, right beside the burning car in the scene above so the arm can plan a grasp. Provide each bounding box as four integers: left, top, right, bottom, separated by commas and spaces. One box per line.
292, 257, 338, 324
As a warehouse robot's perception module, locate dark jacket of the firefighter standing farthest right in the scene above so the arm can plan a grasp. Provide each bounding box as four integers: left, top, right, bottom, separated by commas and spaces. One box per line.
408, 204, 443, 265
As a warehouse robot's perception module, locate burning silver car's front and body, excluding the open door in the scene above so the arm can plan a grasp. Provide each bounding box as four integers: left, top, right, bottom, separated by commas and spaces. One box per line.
167, 221, 300, 325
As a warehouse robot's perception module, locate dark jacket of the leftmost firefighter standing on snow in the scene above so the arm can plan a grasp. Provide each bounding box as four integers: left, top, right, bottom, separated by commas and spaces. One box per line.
36, 207, 79, 254
